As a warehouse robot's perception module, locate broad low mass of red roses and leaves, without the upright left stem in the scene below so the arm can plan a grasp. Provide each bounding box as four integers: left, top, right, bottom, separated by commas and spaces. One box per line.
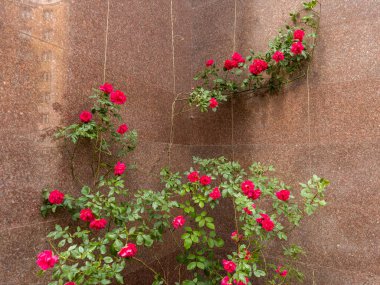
37, 131, 328, 285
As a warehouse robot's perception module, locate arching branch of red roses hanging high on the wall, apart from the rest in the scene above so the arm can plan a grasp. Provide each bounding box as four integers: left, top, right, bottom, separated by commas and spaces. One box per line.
188, 0, 319, 112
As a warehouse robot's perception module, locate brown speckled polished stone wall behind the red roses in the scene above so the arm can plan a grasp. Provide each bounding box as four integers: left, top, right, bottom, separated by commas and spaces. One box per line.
0, 0, 380, 285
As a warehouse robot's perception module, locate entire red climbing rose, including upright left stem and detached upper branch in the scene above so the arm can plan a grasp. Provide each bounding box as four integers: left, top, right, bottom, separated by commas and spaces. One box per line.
36, 1, 329, 285
